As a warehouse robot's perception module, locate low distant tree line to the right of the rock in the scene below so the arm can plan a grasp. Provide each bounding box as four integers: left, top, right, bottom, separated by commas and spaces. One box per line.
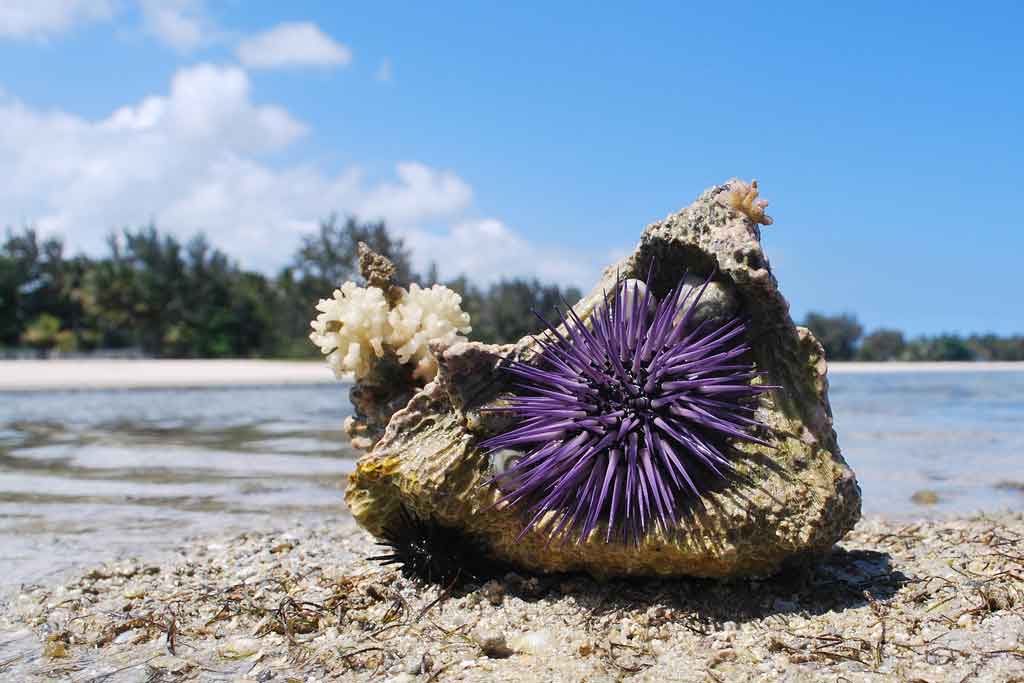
804, 312, 1024, 360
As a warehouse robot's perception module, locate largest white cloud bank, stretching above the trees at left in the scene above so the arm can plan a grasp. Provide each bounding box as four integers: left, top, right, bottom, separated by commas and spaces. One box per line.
0, 65, 603, 288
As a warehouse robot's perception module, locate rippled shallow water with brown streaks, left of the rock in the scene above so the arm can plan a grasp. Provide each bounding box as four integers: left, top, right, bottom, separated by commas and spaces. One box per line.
0, 386, 353, 585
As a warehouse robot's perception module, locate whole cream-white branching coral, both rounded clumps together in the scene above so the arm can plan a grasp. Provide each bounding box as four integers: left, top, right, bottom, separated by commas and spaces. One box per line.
309, 282, 472, 381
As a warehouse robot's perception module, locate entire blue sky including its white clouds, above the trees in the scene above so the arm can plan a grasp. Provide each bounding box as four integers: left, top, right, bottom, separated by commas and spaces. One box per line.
0, 0, 1024, 334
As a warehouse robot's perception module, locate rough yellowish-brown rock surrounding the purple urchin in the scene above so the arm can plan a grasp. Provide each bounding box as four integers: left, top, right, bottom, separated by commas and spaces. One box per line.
345, 181, 860, 578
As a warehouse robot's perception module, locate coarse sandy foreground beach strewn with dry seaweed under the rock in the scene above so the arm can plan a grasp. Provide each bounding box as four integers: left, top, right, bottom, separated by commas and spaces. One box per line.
0, 513, 1024, 683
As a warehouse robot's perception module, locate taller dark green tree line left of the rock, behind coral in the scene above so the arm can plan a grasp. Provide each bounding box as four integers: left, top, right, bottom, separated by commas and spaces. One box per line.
0, 216, 581, 357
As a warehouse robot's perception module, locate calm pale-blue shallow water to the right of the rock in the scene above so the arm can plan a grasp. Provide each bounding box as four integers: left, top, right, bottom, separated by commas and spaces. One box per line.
829, 371, 1024, 517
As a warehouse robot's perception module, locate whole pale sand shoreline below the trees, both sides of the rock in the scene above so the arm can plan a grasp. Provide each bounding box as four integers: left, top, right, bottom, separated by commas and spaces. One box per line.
0, 359, 1024, 391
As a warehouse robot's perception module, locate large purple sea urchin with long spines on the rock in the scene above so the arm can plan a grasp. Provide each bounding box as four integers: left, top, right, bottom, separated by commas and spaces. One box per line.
481, 270, 775, 544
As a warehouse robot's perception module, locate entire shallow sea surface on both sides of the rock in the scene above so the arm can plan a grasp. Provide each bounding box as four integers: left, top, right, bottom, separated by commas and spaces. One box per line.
0, 372, 1024, 586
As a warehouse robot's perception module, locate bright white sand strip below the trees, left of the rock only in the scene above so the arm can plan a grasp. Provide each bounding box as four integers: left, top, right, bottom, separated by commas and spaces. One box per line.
0, 360, 337, 391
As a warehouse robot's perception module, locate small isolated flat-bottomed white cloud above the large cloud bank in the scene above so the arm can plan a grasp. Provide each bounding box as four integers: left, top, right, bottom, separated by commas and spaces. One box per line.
239, 22, 352, 69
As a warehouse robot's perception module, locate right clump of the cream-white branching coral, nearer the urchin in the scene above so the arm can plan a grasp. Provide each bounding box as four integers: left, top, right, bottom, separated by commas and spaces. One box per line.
387, 285, 472, 381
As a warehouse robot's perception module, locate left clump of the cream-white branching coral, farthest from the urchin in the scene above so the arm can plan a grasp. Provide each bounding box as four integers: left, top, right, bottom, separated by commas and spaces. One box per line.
309, 283, 391, 379
